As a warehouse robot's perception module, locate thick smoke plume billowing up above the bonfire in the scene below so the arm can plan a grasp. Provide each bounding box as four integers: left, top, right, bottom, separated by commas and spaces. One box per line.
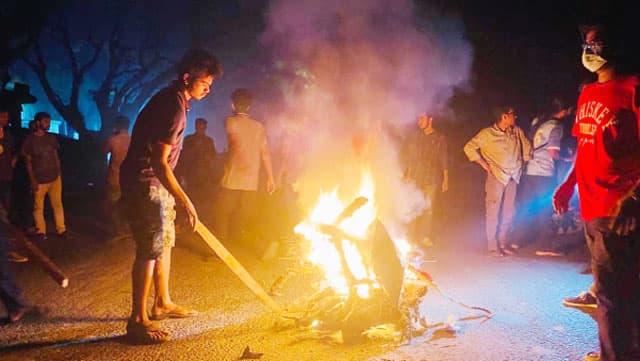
261, 0, 472, 235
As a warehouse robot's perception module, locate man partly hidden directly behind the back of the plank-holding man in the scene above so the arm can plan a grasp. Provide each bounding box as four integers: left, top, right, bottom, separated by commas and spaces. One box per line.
103, 115, 131, 238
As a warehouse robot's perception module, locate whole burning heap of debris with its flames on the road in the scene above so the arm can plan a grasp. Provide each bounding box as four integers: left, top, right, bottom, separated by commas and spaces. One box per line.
270, 172, 490, 343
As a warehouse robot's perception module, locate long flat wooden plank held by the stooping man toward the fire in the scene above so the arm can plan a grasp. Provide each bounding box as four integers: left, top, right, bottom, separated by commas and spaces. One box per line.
196, 221, 283, 312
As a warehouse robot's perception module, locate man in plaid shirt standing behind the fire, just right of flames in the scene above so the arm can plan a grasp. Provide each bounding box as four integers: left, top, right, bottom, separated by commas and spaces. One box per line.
404, 114, 449, 246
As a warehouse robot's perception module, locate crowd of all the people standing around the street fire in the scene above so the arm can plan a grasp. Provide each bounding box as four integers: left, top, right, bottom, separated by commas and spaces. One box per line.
0, 19, 640, 360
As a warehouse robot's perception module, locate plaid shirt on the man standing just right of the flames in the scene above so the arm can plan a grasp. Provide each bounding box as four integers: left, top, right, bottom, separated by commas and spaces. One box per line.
404, 130, 448, 186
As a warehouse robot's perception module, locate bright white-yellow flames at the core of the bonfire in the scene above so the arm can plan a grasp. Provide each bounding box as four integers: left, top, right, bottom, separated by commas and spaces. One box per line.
294, 167, 380, 298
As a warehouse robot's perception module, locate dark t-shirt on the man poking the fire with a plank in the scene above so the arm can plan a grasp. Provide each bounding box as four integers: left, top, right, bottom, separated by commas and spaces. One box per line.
120, 83, 188, 190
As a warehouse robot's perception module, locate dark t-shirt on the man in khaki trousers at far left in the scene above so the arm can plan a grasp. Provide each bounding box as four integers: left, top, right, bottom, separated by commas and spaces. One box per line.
22, 133, 60, 184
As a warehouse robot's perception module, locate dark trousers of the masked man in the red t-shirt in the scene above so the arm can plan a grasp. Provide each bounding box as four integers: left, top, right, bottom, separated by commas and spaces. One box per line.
585, 218, 640, 361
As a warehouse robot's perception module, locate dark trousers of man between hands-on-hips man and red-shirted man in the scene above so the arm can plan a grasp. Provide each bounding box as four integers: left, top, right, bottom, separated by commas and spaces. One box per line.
516, 175, 556, 246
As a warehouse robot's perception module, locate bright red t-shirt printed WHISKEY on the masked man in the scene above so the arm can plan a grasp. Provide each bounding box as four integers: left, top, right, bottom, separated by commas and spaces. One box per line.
572, 77, 640, 221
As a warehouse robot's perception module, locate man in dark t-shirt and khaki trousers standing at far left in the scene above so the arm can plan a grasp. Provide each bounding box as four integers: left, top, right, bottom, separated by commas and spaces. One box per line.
22, 112, 67, 239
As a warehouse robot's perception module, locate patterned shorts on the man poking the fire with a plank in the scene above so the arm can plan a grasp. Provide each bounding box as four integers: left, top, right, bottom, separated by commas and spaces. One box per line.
122, 185, 176, 260
